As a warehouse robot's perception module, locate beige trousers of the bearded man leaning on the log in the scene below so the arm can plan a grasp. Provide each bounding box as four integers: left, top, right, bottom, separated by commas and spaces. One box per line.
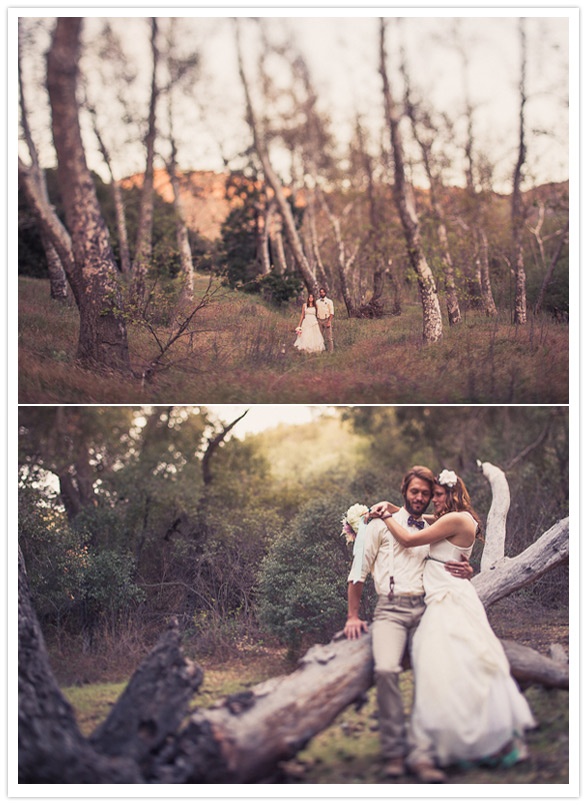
371, 595, 431, 766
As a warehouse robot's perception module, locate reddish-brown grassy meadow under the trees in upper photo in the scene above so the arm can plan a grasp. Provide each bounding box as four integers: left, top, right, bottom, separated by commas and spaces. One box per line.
19, 277, 568, 404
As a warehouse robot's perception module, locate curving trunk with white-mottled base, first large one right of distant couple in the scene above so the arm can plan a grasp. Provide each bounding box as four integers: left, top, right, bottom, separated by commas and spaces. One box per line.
379, 19, 442, 344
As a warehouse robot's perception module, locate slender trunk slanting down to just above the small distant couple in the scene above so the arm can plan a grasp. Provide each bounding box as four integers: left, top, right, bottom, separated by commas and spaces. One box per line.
235, 20, 318, 294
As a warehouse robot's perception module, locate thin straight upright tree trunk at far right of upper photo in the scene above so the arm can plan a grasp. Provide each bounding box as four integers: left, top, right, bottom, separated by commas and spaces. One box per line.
512, 19, 527, 324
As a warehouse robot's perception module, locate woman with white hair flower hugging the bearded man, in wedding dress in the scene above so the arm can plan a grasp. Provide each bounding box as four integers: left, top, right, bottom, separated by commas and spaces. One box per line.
371, 470, 535, 766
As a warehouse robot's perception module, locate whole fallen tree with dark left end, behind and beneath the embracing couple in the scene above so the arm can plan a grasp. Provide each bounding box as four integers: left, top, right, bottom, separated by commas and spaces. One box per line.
18, 458, 569, 783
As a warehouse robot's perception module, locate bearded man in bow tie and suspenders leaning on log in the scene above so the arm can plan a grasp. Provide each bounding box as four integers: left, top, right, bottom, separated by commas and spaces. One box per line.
344, 466, 473, 783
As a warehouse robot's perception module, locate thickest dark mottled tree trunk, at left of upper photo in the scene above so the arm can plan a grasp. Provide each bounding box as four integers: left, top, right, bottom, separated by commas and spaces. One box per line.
47, 17, 130, 369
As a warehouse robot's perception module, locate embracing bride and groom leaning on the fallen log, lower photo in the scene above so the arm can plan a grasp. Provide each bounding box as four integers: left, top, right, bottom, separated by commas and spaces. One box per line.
344, 466, 535, 783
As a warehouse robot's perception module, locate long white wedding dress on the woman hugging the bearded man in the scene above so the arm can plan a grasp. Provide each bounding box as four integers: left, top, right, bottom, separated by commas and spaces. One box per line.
411, 516, 535, 766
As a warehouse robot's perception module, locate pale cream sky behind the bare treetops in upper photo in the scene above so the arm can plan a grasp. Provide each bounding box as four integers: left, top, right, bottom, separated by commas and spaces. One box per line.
19, 8, 571, 190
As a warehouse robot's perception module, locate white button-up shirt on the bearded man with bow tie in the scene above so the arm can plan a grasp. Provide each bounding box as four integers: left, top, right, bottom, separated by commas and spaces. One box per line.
348, 506, 429, 595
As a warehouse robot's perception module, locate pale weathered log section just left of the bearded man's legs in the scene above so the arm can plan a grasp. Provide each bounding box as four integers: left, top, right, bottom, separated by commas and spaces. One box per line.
158, 636, 373, 783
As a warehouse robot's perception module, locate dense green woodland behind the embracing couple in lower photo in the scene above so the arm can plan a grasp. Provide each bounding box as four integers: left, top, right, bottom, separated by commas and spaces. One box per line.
19, 406, 569, 783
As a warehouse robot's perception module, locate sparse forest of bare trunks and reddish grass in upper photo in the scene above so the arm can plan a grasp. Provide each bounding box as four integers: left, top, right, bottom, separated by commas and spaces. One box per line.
18, 17, 569, 403
